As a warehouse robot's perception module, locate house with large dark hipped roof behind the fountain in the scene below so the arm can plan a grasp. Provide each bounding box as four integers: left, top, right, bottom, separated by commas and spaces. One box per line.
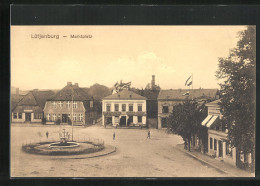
44, 82, 97, 125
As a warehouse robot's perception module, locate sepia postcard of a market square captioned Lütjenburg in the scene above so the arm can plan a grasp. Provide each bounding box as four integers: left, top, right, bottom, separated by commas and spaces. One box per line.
10, 25, 256, 178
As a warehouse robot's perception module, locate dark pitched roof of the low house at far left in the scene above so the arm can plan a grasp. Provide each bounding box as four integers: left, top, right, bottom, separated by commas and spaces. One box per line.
17, 91, 54, 109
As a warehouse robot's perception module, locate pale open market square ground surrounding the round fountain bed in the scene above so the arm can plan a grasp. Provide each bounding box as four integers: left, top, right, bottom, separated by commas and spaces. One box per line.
11, 124, 244, 177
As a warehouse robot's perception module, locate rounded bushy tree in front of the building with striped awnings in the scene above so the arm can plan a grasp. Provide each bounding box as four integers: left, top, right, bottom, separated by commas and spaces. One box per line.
167, 100, 206, 151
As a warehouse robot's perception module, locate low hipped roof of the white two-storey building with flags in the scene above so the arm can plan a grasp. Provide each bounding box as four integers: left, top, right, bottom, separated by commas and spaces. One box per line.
103, 89, 146, 100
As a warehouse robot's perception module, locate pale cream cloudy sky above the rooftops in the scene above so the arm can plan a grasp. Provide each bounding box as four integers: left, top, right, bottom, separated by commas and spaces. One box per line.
11, 26, 246, 90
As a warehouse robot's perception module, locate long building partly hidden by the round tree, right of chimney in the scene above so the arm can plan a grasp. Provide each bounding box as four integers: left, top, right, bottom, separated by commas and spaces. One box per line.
157, 89, 218, 129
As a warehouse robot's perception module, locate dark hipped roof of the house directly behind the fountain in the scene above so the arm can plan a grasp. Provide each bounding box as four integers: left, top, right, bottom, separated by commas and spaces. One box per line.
48, 85, 91, 101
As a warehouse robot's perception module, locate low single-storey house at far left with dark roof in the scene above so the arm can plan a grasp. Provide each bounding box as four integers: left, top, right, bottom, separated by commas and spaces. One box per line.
11, 89, 54, 123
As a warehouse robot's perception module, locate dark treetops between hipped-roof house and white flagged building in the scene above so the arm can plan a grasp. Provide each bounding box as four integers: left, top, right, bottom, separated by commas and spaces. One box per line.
83, 83, 112, 100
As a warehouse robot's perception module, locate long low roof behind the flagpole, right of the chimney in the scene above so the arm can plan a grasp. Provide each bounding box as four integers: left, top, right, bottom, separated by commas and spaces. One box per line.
158, 89, 218, 100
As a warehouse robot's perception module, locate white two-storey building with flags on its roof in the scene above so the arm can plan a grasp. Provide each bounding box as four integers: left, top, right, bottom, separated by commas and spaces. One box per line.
102, 89, 146, 126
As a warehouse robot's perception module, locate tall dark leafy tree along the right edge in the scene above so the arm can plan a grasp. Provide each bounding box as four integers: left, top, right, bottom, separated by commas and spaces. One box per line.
216, 26, 256, 169
